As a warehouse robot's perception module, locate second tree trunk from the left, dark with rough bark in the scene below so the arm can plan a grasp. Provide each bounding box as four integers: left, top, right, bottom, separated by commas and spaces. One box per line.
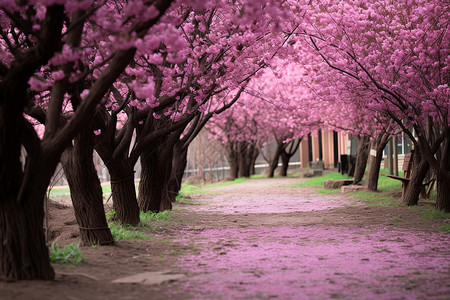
62, 128, 114, 246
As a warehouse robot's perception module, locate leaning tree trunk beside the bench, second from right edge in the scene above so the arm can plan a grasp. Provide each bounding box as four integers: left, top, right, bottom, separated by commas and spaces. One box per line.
403, 148, 430, 206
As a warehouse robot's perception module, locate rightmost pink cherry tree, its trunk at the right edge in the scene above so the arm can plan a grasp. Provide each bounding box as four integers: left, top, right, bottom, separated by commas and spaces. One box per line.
299, 0, 450, 211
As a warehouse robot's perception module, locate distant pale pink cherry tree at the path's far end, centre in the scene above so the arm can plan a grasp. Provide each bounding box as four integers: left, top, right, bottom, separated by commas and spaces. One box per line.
249, 60, 323, 177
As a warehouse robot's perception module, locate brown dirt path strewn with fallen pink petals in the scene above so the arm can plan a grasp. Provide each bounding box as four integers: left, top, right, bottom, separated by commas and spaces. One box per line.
0, 178, 450, 300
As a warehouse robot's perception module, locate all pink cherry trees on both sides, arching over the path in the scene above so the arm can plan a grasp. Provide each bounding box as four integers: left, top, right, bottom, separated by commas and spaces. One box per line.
0, 0, 450, 279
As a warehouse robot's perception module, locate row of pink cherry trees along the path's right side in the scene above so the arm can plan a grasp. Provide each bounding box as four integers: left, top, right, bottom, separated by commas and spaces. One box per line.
211, 0, 450, 211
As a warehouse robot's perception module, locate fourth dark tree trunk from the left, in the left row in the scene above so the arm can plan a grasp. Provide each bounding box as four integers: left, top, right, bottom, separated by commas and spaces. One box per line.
138, 134, 179, 212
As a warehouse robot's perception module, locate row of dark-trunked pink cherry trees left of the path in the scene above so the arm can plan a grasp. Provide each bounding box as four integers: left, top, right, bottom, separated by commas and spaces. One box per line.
0, 0, 296, 279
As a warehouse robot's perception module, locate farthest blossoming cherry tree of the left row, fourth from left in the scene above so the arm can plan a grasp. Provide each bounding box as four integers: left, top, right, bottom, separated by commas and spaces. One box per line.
134, 2, 302, 211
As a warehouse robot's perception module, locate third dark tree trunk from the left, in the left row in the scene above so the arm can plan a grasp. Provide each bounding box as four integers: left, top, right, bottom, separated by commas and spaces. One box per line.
106, 159, 140, 226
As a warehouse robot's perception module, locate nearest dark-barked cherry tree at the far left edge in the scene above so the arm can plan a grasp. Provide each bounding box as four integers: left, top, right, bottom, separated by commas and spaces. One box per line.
0, 1, 176, 279
